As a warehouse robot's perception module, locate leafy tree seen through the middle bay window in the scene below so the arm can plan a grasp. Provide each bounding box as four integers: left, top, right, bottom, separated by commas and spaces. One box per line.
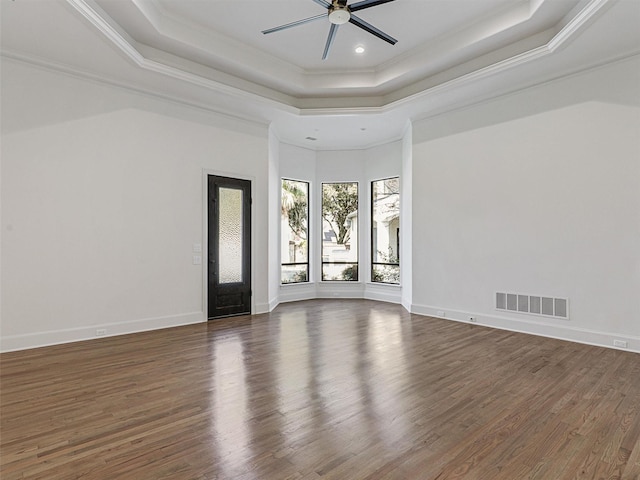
322, 183, 358, 245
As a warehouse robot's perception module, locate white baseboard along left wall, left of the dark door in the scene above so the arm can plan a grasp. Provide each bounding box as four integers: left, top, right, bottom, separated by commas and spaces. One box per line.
0, 312, 207, 352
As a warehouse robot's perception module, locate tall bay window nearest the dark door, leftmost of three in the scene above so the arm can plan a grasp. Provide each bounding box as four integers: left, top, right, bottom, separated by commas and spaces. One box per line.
280, 179, 309, 283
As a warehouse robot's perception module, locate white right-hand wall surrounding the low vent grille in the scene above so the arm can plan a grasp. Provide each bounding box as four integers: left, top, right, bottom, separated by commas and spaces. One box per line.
412, 59, 640, 351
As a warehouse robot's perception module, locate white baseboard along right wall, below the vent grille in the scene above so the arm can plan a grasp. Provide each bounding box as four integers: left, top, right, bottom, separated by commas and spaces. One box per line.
409, 304, 640, 353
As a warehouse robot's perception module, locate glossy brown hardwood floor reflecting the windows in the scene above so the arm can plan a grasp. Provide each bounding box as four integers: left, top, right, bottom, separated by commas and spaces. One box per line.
0, 300, 640, 480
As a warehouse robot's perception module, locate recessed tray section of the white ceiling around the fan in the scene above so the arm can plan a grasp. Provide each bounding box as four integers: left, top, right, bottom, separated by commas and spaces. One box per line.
90, 0, 586, 99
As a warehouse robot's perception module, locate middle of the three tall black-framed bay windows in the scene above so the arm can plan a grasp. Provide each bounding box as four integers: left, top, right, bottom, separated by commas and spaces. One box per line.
322, 182, 358, 281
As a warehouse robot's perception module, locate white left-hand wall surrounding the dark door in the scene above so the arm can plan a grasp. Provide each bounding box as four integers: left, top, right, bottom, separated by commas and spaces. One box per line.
2, 61, 268, 350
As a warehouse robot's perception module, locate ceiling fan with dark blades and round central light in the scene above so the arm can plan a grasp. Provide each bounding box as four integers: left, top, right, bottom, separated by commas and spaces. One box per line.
262, 0, 397, 60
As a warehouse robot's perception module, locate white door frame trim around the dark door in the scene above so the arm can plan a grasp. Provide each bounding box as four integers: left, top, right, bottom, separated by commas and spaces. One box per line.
202, 168, 256, 322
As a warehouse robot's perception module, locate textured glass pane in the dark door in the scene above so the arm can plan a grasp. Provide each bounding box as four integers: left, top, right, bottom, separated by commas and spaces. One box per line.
218, 187, 243, 284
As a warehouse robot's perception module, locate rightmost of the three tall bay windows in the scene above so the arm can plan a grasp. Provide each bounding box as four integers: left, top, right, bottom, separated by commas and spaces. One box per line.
371, 177, 400, 284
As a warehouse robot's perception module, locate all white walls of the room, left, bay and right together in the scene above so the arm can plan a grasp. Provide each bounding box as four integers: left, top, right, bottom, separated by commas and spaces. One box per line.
5, 51, 640, 351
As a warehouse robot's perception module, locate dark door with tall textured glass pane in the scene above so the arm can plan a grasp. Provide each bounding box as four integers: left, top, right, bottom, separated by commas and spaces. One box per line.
208, 175, 251, 318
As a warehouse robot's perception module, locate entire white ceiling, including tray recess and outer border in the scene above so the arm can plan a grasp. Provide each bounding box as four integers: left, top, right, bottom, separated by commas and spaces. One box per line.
1, 0, 640, 149
